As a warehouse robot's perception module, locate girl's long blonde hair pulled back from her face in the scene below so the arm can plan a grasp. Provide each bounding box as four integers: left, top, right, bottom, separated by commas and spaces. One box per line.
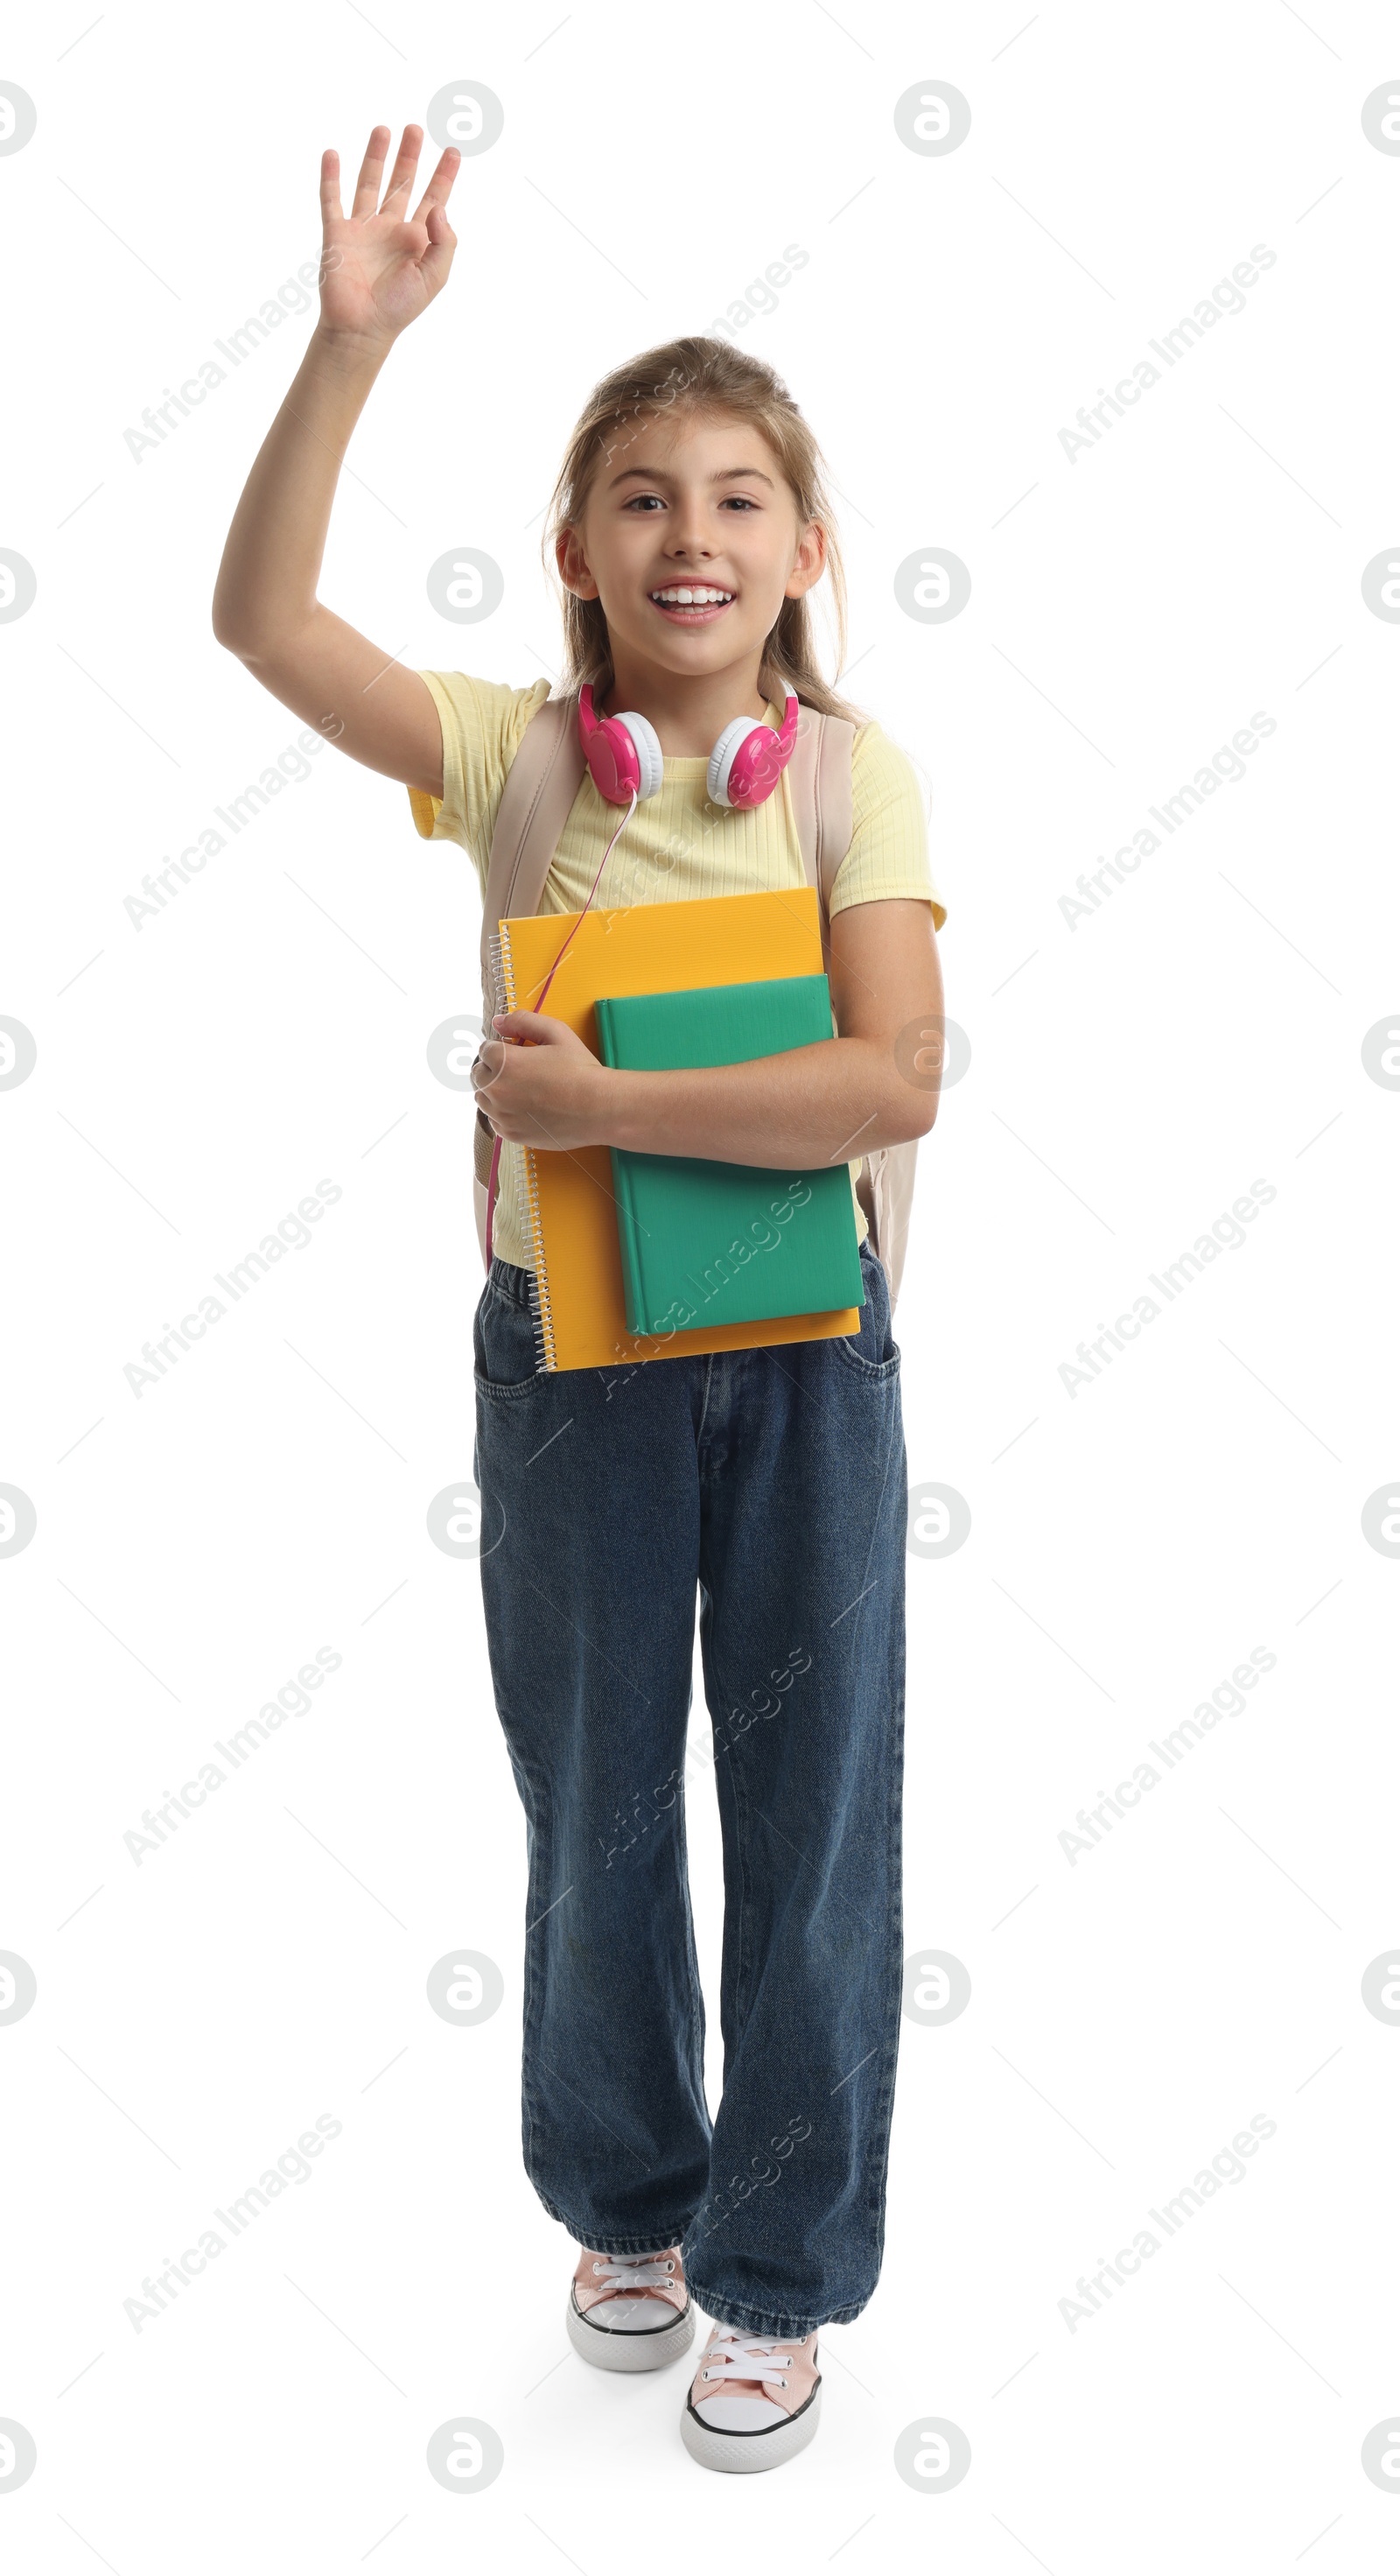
543, 338, 862, 724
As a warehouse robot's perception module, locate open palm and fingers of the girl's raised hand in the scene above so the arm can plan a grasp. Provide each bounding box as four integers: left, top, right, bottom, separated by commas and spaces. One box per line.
322, 126, 460, 342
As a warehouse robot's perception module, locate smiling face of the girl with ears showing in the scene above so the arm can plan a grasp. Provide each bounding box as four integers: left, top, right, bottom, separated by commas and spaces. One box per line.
558, 415, 826, 711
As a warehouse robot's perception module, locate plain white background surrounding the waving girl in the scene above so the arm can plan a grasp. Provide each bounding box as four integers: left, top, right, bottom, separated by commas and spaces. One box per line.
0, 0, 1400, 2576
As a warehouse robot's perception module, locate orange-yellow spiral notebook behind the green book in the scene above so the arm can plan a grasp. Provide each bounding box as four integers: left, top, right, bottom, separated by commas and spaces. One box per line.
492, 886, 859, 1368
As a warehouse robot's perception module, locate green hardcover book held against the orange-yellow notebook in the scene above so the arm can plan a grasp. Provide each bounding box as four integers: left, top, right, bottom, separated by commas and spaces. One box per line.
597, 973, 864, 1332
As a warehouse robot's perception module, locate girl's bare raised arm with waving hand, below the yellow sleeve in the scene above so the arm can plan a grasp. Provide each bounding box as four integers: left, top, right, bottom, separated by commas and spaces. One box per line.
214, 126, 460, 796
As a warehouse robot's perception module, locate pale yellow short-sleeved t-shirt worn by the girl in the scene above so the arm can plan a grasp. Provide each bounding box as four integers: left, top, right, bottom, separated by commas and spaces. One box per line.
410, 670, 947, 1270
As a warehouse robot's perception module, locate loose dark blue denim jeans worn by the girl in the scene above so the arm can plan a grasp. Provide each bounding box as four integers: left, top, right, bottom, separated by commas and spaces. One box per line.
473, 1244, 908, 2336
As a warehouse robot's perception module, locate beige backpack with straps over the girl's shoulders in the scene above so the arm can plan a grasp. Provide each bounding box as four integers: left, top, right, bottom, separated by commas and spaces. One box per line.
473, 698, 919, 1314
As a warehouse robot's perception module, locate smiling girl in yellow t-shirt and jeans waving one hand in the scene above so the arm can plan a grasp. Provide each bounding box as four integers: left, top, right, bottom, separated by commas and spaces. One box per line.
214, 126, 942, 2470
